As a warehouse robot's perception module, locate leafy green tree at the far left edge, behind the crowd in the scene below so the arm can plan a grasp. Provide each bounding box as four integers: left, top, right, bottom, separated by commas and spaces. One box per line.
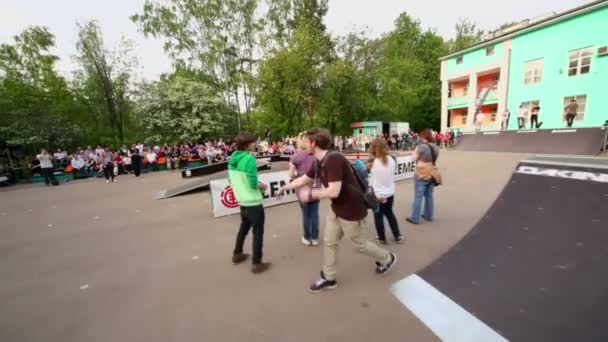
0, 27, 84, 150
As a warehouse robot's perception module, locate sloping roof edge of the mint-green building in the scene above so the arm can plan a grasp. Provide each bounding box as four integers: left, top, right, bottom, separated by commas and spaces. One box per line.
439, 0, 608, 60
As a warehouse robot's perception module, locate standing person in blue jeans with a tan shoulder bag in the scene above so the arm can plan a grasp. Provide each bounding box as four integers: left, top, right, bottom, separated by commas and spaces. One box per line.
407, 129, 439, 224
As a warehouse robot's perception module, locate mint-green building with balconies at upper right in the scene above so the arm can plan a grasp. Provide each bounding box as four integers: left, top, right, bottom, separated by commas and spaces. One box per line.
441, 0, 608, 131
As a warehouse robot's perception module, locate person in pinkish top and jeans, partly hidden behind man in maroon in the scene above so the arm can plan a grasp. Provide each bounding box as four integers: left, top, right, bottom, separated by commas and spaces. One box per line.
289, 134, 319, 246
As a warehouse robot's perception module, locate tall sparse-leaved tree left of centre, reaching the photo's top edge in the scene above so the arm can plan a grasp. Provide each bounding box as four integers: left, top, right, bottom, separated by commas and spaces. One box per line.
131, 0, 263, 131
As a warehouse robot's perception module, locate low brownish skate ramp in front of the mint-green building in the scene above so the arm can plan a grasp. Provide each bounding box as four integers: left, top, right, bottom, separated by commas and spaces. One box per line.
456, 127, 608, 156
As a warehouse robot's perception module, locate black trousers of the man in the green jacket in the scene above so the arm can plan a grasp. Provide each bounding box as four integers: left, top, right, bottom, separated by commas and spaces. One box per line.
234, 204, 266, 264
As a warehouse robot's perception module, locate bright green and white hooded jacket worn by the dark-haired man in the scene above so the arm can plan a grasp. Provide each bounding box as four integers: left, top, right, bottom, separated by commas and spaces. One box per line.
228, 151, 263, 207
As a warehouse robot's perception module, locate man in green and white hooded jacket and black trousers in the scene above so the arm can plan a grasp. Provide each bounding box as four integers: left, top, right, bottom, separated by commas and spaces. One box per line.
228, 133, 270, 274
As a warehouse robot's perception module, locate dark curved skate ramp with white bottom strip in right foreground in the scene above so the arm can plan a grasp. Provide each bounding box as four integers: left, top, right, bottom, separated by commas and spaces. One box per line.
391, 156, 608, 342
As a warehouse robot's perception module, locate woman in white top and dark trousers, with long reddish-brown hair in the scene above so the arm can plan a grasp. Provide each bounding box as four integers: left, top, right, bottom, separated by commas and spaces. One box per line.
370, 139, 403, 244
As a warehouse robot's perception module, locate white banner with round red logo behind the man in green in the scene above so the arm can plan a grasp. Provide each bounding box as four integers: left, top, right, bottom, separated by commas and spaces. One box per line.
209, 171, 298, 217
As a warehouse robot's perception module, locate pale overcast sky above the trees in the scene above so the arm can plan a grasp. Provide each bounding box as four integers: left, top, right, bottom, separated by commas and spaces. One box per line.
0, 0, 590, 79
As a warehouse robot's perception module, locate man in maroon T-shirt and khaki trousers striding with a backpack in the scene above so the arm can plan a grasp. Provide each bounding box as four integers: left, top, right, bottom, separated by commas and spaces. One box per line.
278, 128, 397, 293
